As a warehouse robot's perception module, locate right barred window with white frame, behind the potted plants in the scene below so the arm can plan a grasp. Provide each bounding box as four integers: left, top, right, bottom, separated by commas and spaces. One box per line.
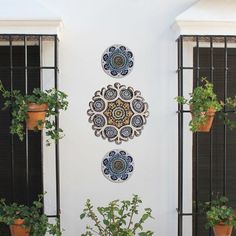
178, 36, 236, 236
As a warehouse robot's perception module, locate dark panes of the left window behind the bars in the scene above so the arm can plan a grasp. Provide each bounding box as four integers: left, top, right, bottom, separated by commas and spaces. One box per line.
0, 46, 43, 236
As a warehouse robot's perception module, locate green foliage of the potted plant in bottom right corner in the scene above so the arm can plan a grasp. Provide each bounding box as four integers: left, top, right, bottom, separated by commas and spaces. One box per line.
200, 195, 236, 228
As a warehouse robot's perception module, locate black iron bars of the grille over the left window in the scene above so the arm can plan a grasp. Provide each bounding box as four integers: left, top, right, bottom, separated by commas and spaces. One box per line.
0, 34, 60, 219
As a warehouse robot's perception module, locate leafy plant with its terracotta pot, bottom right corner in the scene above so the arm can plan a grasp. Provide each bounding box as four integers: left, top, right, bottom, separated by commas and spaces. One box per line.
201, 195, 236, 236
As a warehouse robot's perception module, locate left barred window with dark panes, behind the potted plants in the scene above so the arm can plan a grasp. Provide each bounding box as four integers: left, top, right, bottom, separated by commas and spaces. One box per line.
0, 35, 59, 236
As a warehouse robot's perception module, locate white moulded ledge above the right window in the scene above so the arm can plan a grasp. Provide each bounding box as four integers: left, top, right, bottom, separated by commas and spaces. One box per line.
172, 0, 236, 36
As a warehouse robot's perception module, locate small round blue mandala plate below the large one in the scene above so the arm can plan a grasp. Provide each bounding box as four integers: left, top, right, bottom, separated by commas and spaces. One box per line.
102, 149, 134, 183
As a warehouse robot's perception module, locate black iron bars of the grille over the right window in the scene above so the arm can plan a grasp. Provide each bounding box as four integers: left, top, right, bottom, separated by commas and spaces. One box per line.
177, 35, 236, 236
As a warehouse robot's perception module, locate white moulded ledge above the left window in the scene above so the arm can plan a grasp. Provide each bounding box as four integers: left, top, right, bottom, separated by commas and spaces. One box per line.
0, 0, 62, 35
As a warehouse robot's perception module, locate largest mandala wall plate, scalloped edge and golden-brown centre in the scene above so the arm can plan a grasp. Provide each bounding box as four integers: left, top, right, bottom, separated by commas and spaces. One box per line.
87, 83, 149, 144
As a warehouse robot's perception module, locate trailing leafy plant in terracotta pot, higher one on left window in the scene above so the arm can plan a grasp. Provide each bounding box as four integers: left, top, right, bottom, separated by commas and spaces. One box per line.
0, 81, 68, 145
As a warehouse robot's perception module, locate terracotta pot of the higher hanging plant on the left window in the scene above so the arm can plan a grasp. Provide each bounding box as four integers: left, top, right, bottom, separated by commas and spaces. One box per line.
27, 103, 48, 130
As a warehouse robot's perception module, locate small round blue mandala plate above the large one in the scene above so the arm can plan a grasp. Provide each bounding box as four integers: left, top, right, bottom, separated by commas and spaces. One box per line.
102, 44, 134, 78
